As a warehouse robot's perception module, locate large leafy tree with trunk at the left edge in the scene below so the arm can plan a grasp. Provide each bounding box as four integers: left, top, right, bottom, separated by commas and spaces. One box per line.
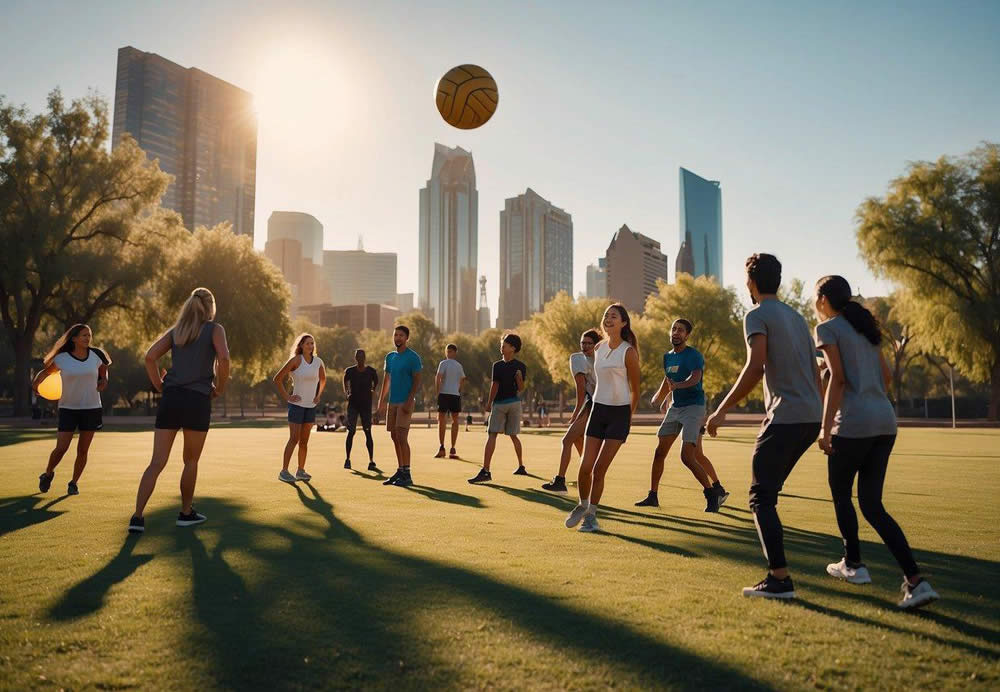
0, 90, 172, 415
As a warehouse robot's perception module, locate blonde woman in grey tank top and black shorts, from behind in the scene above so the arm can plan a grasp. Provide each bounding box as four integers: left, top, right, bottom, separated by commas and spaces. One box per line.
128, 288, 229, 533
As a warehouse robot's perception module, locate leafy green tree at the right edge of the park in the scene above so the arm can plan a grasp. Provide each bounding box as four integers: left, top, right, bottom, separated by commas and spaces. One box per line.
857, 143, 1000, 420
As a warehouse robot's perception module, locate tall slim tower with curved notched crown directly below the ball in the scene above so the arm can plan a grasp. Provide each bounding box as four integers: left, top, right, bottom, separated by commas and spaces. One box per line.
417, 144, 479, 334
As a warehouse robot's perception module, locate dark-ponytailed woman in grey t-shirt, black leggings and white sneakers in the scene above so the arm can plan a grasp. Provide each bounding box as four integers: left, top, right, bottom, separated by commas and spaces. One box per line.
816, 276, 939, 608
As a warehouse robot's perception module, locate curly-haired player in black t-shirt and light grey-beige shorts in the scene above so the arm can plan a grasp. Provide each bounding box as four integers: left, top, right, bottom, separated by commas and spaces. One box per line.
469, 334, 528, 483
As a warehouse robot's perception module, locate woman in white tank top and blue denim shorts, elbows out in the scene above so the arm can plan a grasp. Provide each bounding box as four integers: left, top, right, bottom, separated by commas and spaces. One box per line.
273, 334, 326, 483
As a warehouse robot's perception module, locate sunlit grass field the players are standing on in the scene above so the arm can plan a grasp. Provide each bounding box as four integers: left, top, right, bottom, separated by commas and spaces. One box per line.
0, 425, 1000, 690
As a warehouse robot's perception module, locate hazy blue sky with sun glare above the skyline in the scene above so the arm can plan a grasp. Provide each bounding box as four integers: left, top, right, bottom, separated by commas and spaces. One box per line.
0, 0, 1000, 315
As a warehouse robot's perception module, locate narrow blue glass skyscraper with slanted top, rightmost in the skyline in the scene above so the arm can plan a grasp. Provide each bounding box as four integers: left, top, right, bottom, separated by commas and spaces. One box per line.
680, 168, 722, 285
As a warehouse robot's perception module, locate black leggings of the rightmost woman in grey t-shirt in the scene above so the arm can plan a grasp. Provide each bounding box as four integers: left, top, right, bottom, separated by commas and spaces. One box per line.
827, 435, 920, 577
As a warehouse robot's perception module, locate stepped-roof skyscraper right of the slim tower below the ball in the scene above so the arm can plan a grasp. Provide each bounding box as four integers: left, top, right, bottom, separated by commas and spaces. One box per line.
498, 187, 573, 328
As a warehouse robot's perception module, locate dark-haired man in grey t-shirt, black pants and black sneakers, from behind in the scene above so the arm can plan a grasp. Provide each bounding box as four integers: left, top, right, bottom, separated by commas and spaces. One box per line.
707, 254, 823, 598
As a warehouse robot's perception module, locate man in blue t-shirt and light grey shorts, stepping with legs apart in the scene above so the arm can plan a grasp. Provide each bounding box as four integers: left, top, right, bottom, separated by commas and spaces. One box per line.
635, 318, 729, 512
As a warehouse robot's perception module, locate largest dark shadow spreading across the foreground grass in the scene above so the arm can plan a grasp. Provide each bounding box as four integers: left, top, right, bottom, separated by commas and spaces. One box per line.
119, 488, 769, 690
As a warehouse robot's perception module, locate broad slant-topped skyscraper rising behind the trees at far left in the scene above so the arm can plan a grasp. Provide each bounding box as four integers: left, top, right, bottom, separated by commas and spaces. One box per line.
112, 46, 257, 236
